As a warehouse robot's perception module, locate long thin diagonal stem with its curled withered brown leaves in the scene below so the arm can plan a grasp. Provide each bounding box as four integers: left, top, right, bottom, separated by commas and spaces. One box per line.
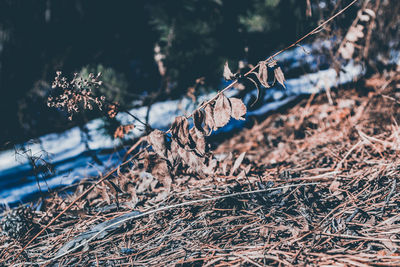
12, 0, 358, 264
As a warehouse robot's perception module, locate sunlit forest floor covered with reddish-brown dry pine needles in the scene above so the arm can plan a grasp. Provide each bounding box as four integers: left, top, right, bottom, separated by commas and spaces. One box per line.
0, 70, 400, 266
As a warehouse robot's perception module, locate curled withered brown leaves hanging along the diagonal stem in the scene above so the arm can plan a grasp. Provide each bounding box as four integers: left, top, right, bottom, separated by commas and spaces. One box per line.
147, 58, 285, 178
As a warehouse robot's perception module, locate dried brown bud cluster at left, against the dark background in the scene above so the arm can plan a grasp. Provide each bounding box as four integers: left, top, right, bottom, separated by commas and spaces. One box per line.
47, 71, 106, 120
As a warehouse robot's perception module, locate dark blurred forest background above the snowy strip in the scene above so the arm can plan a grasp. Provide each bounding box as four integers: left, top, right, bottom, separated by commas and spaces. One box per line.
0, 0, 356, 149
